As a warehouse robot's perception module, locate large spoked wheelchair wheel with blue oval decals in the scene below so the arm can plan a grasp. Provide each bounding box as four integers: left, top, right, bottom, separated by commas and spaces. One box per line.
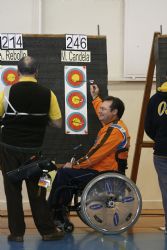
80, 172, 142, 234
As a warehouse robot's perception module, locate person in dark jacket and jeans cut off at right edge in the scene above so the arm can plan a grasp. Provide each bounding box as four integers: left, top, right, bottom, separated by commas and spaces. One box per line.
145, 75, 167, 234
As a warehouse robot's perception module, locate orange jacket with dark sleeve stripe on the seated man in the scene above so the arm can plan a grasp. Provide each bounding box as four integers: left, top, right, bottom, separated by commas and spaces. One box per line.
72, 97, 130, 171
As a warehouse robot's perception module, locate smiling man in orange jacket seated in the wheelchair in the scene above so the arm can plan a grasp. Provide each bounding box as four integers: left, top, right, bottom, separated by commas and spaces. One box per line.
48, 84, 130, 229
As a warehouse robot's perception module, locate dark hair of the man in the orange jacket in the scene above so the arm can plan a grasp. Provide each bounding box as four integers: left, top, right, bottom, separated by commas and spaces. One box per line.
103, 96, 125, 119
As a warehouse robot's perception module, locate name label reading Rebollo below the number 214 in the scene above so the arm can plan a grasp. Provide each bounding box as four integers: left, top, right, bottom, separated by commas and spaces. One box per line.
0, 50, 28, 62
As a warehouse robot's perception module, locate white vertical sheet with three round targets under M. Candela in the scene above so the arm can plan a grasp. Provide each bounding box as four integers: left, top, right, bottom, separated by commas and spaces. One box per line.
64, 66, 88, 134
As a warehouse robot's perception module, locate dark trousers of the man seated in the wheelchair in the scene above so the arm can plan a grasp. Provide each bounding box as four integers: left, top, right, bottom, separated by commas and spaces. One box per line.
48, 168, 98, 210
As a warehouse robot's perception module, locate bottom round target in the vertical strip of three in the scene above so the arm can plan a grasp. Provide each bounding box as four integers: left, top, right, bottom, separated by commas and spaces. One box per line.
67, 113, 86, 132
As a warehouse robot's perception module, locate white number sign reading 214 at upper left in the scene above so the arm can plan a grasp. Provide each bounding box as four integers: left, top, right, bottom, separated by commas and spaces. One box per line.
0, 33, 23, 50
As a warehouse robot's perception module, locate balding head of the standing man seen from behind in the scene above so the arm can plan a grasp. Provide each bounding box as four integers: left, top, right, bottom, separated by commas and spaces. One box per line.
18, 56, 38, 75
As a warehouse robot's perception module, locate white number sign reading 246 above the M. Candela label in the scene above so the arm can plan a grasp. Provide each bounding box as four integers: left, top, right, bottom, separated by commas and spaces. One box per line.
66, 35, 87, 50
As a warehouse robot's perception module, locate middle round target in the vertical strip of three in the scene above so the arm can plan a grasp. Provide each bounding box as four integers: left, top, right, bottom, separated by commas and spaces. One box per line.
66, 91, 86, 109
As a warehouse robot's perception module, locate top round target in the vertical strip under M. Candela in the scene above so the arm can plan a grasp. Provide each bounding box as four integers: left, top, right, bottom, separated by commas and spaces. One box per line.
66, 68, 85, 88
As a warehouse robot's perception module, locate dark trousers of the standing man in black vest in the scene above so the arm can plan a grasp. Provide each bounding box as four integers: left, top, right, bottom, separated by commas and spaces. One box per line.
0, 146, 54, 236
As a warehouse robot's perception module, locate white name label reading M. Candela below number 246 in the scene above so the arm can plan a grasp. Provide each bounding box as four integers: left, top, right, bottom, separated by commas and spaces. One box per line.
61, 50, 91, 63
